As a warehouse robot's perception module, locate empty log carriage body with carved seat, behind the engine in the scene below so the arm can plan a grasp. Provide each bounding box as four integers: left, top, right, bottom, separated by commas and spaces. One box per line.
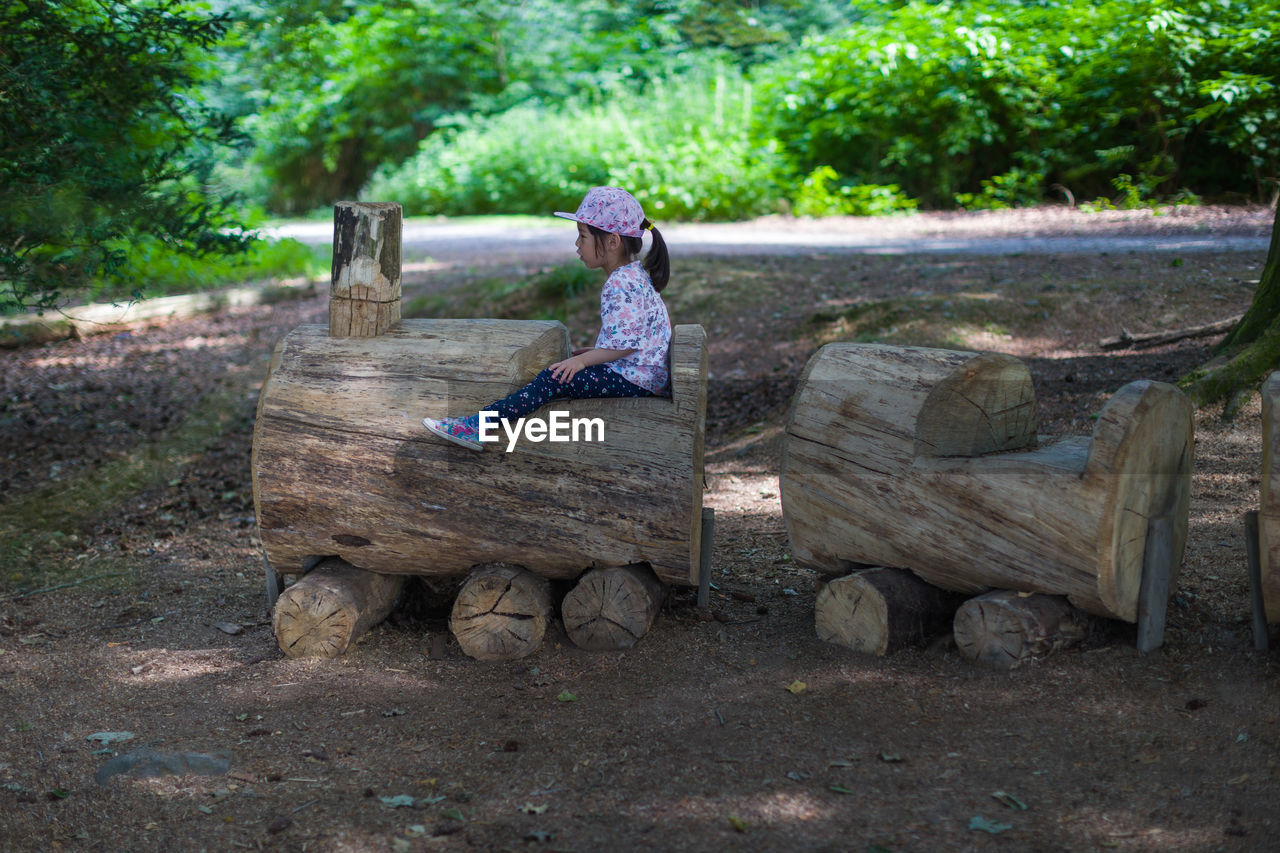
781, 345, 1193, 622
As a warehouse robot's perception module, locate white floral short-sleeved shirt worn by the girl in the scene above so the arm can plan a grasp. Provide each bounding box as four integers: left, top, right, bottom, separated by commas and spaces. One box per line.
595, 261, 671, 394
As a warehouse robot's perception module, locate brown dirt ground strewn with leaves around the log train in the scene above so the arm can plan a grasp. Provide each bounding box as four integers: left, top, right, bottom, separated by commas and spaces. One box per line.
0, 210, 1280, 852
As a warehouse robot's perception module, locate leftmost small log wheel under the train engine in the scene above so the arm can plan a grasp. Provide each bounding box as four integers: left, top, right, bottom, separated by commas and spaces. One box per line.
271, 557, 404, 657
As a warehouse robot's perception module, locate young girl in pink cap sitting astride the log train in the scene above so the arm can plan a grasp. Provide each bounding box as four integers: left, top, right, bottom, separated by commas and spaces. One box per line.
422, 187, 671, 450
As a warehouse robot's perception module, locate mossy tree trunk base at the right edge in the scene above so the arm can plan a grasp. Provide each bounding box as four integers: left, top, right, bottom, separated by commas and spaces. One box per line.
1179, 206, 1280, 406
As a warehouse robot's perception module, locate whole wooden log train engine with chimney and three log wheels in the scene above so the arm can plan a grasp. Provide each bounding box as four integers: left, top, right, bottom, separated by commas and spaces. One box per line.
252, 202, 710, 660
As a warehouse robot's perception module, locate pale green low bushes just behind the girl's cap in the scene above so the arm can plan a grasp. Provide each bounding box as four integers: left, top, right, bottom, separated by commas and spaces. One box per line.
366, 68, 781, 224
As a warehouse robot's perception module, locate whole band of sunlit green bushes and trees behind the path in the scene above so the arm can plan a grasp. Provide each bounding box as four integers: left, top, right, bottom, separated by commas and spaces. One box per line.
219, 0, 1280, 218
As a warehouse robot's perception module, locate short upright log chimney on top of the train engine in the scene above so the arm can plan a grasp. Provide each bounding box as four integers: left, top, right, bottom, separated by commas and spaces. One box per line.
329, 201, 401, 338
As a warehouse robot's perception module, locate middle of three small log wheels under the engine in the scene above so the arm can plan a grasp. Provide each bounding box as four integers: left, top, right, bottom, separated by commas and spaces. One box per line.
449, 562, 552, 661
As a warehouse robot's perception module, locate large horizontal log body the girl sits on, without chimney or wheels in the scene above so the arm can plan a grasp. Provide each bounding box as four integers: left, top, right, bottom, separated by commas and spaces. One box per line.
252, 320, 707, 585
